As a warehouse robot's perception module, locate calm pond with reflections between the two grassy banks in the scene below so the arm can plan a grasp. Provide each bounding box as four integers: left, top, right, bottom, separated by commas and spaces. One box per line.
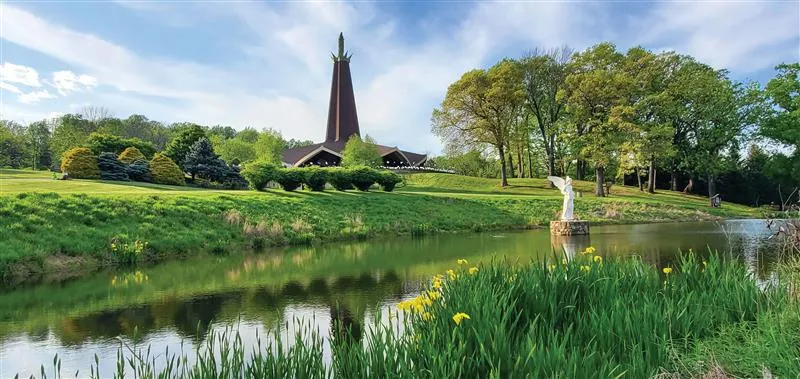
0, 220, 776, 377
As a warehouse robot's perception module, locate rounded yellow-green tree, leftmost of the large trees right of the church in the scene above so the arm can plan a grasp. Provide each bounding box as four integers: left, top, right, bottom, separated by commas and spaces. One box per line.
432, 59, 525, 187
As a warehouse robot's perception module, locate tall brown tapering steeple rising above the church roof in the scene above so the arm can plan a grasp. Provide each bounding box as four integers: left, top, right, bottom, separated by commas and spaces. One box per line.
325, 33, 361, 142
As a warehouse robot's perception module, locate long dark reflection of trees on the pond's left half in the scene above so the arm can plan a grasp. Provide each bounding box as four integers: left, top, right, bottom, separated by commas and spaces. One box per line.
43, 271, 404, 345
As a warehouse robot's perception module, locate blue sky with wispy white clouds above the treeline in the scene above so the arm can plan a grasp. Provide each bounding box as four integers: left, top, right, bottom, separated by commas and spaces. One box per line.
0, 0, 800, 153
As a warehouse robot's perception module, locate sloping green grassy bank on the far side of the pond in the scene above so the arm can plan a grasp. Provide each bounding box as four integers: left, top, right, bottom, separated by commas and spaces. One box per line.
0, 170, 755, 283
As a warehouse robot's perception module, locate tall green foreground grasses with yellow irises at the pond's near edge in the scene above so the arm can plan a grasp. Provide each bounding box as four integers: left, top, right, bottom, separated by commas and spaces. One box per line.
32, 254, 800, 378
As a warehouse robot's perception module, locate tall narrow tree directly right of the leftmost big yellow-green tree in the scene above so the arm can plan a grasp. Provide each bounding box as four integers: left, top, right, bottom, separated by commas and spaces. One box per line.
521, 47, 572, 185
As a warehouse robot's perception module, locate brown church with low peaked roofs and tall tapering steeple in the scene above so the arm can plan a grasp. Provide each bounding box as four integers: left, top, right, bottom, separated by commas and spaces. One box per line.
283, 33, 428, 167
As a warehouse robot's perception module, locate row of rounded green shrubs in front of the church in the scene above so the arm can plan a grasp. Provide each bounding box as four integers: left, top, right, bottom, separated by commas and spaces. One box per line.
242, 162, 403, 192
